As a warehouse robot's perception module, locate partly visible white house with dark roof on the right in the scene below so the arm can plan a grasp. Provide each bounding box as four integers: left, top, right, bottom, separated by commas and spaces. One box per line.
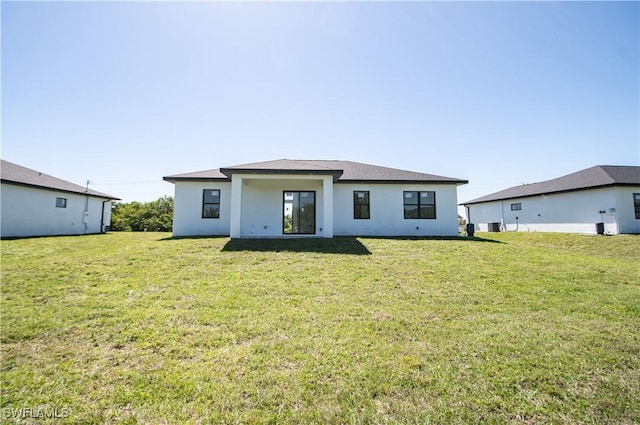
462, 165, 640, 234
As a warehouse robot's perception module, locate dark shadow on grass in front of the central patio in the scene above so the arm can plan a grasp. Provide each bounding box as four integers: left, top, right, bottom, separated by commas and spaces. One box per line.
222, 236, 371, 255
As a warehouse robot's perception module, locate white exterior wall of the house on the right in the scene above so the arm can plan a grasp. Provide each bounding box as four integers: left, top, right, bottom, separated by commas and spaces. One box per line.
467, 187, 640, 234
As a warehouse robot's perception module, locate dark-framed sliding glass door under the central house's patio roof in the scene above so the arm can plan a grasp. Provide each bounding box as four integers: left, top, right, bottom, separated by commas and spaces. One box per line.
282, 191, 316, 235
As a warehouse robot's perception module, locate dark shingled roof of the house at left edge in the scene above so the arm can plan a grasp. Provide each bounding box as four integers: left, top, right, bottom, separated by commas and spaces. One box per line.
0, 160, 120, 200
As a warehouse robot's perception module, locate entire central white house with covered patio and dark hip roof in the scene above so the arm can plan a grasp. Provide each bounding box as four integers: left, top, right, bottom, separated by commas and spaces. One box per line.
164, 159, 467, 238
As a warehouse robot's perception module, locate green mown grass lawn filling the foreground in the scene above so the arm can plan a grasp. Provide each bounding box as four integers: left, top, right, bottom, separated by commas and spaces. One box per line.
0, 233, 640, 424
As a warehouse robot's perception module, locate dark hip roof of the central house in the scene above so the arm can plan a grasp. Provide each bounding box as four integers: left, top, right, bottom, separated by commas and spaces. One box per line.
164, 159, 468, 184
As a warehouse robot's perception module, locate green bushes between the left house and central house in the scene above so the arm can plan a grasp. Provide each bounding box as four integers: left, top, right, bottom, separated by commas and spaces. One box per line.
111, 196, 173, 232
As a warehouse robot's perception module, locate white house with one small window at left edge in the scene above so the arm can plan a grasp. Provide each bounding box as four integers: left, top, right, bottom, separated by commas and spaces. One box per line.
0, 160, 118, 238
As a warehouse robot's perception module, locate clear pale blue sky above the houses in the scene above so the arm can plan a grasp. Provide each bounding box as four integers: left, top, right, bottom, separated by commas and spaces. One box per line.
1, 2, 640, 207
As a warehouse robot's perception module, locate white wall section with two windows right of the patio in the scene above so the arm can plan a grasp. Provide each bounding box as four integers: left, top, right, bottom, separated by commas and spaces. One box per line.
333, 183, 458, 236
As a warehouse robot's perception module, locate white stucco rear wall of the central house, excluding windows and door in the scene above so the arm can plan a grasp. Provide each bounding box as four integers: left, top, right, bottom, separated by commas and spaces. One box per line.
173, 174, 458, 238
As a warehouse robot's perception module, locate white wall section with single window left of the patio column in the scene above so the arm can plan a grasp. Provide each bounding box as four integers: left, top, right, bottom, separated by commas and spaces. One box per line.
173, 181, 231, 236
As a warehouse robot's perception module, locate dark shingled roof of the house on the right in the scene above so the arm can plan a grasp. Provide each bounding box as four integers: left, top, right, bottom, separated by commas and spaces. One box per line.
461, 165, 640, 205
